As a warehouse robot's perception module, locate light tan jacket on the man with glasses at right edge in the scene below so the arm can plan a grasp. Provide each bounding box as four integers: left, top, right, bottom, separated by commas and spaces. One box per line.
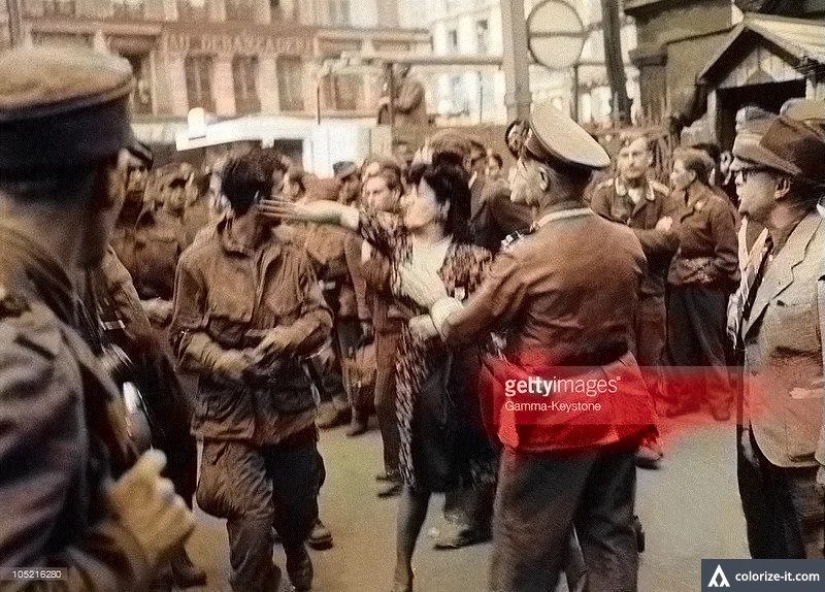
742, 212, 825, 467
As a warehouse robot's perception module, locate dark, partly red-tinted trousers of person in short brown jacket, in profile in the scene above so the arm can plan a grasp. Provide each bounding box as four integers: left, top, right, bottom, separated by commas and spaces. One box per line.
667, 286, 733, 415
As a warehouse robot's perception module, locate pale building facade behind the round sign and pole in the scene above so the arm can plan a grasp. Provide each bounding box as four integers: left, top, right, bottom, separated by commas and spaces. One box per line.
416, 0, 638, 124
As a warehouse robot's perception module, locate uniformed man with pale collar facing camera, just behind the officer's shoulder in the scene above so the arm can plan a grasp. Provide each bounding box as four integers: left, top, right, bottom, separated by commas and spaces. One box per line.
590, 133, 679, 468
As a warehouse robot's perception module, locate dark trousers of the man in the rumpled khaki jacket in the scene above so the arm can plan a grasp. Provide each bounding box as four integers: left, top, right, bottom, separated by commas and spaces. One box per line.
199, 428, 326, 592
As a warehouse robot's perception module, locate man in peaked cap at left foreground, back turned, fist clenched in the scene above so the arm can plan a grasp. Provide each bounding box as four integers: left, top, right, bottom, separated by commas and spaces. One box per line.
0, 47, 194, 590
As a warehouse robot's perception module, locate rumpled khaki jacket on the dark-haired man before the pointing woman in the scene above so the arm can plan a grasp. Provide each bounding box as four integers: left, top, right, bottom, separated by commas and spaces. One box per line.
170, 216, 332, 445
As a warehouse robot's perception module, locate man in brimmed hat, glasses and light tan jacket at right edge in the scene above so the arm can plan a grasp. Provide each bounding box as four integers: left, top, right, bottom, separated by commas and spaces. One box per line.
729, 115, 825, 559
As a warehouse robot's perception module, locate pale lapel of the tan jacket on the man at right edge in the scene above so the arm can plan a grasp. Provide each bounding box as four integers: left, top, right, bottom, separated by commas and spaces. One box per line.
742, 211, 825, 335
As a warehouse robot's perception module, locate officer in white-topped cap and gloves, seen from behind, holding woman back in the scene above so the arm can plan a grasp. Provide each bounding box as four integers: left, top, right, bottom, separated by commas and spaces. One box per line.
400, 104, 654, 592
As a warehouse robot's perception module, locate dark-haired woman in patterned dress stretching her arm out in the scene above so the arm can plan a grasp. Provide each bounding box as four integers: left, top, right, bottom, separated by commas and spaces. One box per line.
263, 165, 497, 592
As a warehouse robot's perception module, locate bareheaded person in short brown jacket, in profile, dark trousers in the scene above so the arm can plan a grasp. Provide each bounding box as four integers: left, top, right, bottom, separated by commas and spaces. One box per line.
665, 149, 739, 421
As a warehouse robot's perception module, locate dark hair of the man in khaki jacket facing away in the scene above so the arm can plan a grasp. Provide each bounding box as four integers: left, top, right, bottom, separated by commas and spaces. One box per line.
222, 150, 287, 215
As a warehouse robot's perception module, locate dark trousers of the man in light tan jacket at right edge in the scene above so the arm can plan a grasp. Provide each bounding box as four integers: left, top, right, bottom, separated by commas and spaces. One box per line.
736, 428, 825, 559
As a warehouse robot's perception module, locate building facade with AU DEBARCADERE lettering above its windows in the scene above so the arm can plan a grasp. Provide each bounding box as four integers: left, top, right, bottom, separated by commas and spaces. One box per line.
6, 0, 430, 123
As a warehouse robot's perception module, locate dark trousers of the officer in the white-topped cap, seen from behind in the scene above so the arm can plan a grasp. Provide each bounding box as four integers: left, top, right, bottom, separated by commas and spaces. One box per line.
490, 449, 639, 592
